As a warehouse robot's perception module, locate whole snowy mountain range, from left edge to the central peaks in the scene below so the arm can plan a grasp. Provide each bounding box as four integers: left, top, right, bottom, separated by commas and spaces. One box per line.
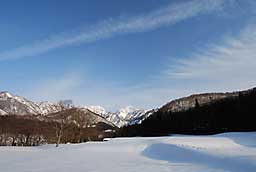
0, 92, 154, 127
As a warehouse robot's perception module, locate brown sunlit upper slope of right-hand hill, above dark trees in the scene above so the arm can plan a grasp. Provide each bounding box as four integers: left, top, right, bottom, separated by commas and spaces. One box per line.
161, 92, 239, 112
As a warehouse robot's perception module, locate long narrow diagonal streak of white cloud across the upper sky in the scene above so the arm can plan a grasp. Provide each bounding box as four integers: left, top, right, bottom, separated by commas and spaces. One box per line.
0, 0, 228, 60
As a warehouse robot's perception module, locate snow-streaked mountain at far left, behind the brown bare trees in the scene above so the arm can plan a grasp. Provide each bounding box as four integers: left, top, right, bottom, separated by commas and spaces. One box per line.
0, 92, 71, 115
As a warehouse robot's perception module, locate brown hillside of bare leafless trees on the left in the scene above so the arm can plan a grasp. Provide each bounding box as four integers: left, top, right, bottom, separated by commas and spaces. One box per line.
0, 108, 115, 146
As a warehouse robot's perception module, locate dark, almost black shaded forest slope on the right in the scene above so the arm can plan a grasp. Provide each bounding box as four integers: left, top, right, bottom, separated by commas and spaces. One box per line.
119, 88, 256, 136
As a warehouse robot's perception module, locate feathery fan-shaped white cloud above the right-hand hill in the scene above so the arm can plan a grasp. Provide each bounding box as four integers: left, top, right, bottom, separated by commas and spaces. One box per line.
162, 23, 256, 91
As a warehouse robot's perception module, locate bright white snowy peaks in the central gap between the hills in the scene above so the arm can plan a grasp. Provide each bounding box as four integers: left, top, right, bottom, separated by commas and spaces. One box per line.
86, 106, 156, 127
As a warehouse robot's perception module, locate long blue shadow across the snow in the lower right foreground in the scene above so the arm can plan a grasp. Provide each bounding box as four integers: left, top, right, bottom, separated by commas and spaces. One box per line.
142, 143, 256, 172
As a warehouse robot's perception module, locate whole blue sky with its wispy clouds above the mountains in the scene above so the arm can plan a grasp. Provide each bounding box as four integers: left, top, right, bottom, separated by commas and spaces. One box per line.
0, 0, 256, 109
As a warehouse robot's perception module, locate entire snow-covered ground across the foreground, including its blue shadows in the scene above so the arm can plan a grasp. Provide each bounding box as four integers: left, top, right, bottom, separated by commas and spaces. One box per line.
0, 132, 256, 172
